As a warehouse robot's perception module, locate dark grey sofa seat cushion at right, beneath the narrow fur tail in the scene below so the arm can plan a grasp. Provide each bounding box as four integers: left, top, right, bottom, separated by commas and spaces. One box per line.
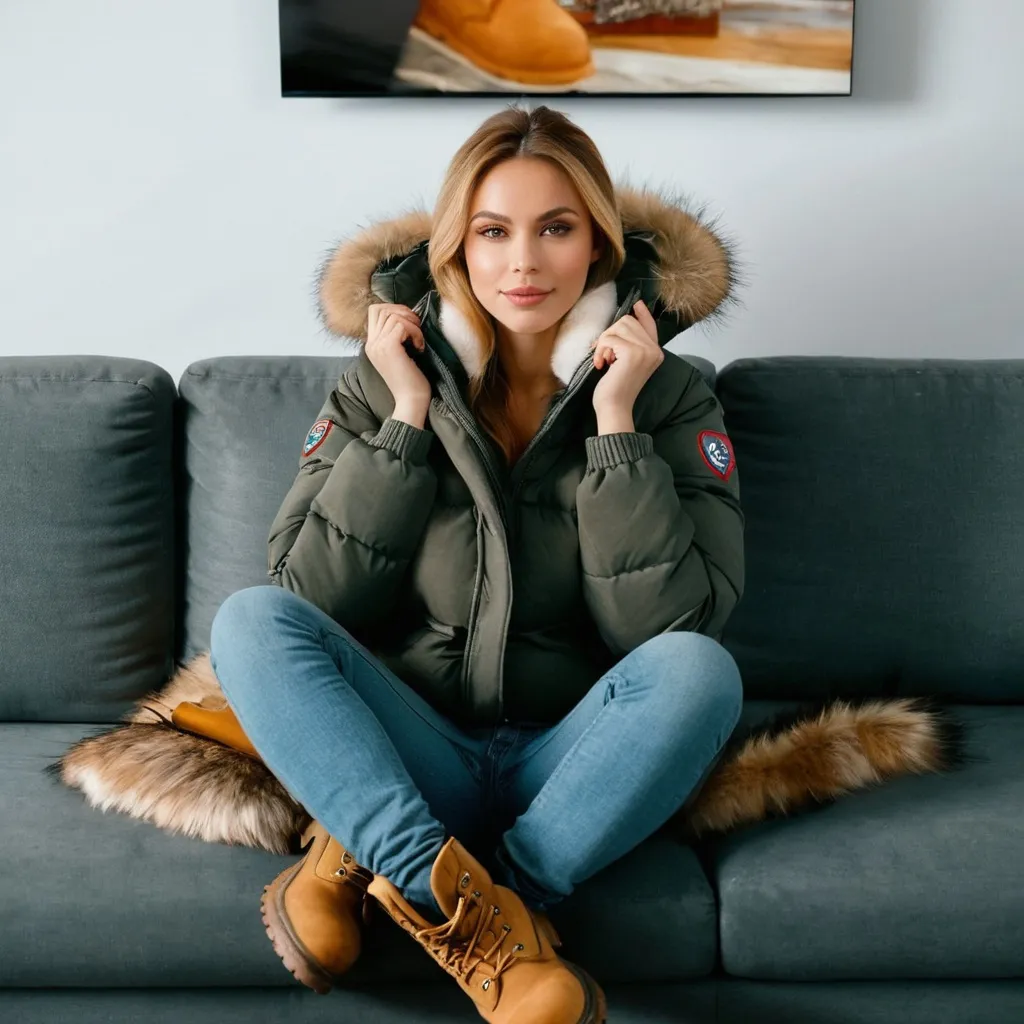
700, 701, 1024, 981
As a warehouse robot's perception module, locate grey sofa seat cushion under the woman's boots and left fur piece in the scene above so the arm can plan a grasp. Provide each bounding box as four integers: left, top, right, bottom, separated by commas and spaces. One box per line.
8, 722, 716, 987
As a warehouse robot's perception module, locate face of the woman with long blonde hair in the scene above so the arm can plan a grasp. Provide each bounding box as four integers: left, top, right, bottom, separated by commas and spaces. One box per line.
463, 157, 600, 335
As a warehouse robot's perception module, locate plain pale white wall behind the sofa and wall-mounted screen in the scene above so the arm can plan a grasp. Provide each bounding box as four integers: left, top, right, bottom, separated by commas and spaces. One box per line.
0, 0, 1024, 380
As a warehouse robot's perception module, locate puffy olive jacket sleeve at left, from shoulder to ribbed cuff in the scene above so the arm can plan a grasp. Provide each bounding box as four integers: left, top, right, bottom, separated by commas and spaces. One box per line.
267, 364, 437, 629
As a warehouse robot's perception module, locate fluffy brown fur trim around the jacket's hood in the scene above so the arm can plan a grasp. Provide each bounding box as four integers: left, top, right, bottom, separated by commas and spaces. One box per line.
316, 183, 738, 341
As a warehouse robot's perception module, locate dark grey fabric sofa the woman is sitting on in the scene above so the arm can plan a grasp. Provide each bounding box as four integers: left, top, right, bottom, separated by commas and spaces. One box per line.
0, 356, 1024, 1024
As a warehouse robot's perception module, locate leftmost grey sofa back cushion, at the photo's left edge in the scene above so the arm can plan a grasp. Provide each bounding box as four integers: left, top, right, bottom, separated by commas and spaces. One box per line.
0, 355, 175, 723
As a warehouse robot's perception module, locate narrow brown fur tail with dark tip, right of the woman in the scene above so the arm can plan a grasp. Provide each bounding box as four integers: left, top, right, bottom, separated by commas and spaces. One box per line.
674, 697, 977, 839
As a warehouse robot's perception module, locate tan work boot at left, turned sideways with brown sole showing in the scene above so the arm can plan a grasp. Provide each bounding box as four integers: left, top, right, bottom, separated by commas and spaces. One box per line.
260, 821, 374, 995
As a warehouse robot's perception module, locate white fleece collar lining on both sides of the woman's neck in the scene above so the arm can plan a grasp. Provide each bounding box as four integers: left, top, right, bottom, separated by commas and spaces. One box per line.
438, 281, 618, 386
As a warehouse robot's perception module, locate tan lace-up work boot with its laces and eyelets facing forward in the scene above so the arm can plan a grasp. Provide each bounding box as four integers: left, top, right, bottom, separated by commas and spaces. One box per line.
368, 836, 607, 1024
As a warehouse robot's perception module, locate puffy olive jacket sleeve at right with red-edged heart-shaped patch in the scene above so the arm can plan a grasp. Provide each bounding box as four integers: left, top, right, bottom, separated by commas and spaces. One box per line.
577, 364, 744, 657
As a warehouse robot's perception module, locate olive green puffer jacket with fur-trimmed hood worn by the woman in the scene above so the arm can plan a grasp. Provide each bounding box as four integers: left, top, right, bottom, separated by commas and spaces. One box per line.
268, 186, 743, 727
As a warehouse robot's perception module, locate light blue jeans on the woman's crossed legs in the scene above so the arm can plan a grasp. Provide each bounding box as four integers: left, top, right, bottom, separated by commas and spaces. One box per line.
210, 584, 742, 910
